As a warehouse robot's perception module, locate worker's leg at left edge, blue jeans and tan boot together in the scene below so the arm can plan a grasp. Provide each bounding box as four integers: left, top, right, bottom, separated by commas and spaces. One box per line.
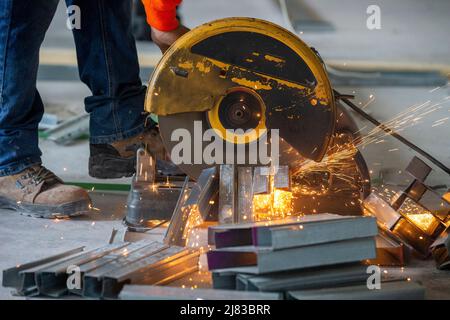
0, 0, 90, 218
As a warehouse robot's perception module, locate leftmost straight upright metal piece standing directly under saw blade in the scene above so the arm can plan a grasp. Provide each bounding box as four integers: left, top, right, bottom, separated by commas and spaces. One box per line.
218, 164, 236, 224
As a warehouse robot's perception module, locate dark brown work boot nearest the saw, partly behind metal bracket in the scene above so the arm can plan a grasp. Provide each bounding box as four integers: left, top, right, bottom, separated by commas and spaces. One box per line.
89, 127, 184, 179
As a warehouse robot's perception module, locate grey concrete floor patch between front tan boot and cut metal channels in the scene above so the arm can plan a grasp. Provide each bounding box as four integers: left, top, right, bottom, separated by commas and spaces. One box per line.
0, 193, 126, 299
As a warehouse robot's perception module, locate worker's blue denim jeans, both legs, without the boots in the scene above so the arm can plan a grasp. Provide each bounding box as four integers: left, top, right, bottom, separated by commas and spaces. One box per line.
0, 0, 146, 176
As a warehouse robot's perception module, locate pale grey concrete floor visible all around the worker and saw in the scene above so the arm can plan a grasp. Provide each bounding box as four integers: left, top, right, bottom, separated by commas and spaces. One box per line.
0, 0, 450, 299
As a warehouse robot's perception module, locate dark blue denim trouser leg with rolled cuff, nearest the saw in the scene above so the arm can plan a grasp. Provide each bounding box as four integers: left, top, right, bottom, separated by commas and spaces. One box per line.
66, 0, 146, 144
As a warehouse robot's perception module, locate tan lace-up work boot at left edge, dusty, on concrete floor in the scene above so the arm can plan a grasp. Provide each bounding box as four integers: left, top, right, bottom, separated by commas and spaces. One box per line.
0, 165, 91, 219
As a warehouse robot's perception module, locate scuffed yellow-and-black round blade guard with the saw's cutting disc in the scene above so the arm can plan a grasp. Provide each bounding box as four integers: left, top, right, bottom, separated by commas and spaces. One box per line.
146, 18, 336, 178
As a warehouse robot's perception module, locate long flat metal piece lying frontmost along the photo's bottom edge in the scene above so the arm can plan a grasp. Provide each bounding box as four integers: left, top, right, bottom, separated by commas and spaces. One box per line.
119, 285, 281, 301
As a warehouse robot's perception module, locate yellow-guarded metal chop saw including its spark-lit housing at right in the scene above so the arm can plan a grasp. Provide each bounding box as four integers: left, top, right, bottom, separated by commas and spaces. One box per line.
145, 18, 368, 218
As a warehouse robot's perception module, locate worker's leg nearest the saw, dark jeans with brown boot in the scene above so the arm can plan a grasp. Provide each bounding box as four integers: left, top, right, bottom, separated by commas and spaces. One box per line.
66, 0, 170, 178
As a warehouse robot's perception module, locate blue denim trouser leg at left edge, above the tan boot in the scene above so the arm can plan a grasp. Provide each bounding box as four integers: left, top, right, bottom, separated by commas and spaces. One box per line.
0, 0, 58, 176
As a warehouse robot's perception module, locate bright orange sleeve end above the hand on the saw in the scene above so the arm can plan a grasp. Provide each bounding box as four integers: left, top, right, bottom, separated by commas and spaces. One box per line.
142, 0, 182, 31
